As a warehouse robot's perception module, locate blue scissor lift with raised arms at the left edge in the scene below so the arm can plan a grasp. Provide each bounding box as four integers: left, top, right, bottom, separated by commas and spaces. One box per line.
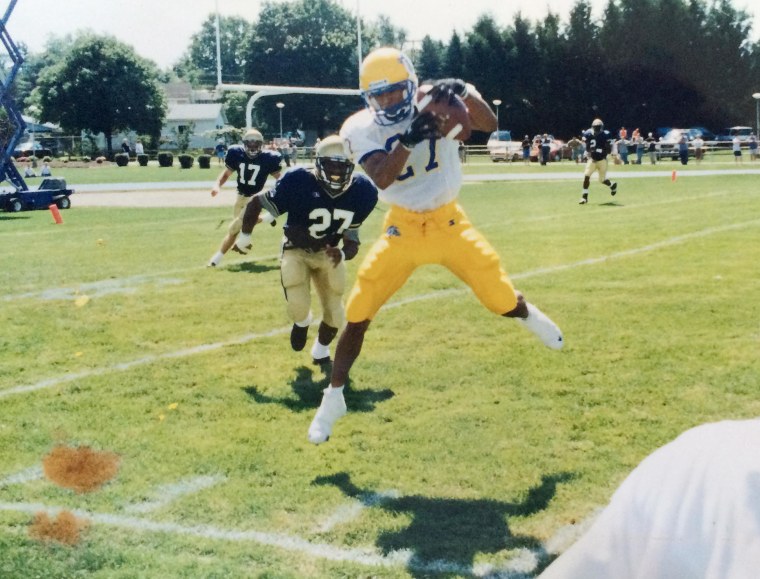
0, 0, 74, 212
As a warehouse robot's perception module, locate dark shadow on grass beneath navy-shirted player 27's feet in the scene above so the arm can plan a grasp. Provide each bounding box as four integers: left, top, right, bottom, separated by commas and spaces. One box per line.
243, 364, 393, 412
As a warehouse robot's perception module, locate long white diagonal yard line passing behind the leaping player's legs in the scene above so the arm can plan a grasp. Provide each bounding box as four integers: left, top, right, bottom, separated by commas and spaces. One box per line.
0, 219, 760, 398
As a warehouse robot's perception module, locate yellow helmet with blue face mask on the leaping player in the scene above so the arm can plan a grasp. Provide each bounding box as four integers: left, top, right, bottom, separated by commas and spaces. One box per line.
359, 47, 419, 126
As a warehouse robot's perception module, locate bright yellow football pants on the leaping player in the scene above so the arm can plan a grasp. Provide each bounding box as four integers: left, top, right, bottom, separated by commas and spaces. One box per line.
346, 202, 517, 323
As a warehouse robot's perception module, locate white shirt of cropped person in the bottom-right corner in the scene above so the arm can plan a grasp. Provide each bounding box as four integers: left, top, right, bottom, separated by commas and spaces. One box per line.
539, 419, 760, 579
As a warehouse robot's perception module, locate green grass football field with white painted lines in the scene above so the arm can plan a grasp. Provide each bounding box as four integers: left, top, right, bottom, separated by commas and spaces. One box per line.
0, 165, 760, 578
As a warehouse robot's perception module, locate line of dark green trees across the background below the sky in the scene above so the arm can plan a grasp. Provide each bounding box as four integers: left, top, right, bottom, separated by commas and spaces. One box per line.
11, 0, 760, 152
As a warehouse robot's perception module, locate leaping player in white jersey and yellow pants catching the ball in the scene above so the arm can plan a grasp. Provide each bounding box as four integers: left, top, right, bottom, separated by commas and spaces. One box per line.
308, 48, 562, 444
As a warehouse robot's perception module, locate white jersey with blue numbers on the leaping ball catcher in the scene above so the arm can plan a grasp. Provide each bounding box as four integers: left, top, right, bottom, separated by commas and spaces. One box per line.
340, 108, 462, 212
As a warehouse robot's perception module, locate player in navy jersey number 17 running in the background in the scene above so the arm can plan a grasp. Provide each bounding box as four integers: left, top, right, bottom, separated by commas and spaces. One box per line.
208, 129, 282, 267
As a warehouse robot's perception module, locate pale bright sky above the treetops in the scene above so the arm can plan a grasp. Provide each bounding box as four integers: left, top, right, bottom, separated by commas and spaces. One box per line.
5, 0, 760, 69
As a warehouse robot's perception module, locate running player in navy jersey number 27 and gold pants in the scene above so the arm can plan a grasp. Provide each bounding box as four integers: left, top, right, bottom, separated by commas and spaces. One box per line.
234, 135, 377, 364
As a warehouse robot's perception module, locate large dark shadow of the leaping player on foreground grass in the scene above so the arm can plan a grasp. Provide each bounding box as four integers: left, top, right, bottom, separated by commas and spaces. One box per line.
312, 472, 575, 577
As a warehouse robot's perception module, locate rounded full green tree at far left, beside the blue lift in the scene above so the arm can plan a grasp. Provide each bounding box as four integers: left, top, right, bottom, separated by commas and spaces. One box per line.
31, 34, 166, 154
